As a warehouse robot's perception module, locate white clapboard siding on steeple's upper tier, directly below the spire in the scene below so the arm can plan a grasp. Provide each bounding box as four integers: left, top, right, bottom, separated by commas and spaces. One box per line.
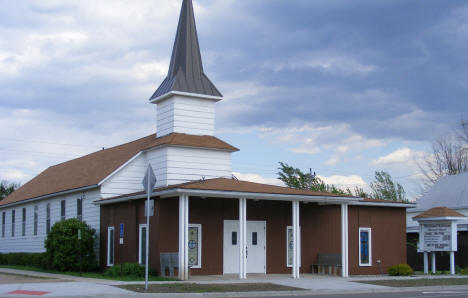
157, 95, 215, 137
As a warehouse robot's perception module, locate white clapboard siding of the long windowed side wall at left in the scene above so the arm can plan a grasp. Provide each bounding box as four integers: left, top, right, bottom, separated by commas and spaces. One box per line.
0, 189, 100, 253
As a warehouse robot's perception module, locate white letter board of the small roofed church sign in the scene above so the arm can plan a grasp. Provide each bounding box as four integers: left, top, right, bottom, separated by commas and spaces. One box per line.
420, 222, 457, 251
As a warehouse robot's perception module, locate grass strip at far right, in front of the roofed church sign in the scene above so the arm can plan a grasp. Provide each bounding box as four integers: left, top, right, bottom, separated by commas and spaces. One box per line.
358, 278, 468, 288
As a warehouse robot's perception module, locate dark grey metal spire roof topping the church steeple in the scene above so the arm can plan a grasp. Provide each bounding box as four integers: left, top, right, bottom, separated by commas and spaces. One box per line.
150, 0, 222, 100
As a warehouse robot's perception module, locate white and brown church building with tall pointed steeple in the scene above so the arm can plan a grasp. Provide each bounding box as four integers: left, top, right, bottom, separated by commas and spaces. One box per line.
0, 0, 411, 280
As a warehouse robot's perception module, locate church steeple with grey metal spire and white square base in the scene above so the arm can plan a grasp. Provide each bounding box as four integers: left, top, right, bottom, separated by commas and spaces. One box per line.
150, 0, 222, 137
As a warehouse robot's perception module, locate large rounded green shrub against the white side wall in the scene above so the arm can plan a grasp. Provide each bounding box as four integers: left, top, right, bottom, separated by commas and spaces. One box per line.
45, 218, 97, 272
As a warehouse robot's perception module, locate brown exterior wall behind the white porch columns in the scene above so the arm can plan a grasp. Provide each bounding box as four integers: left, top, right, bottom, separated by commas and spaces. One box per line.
101, 197, 406, 275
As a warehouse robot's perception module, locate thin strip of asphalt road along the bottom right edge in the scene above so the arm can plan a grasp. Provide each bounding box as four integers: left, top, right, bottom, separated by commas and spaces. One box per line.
238, 290, 468, 298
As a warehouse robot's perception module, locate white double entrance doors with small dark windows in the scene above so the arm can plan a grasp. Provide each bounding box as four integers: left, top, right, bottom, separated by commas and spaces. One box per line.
223, 220, 266, 274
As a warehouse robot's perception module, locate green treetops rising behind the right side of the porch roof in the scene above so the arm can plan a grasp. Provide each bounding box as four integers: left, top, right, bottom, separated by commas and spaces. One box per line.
278, 162, 368, 197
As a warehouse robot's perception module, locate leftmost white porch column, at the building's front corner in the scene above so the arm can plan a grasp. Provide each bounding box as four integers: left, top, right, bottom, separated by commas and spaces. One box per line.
178, 195, 189, 280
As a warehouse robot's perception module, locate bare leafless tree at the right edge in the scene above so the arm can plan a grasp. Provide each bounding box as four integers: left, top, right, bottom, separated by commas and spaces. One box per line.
418, 120, 468, 189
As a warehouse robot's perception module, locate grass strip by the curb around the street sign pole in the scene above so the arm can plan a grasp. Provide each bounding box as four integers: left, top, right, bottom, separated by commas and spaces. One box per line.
119, 283, 304, 293
